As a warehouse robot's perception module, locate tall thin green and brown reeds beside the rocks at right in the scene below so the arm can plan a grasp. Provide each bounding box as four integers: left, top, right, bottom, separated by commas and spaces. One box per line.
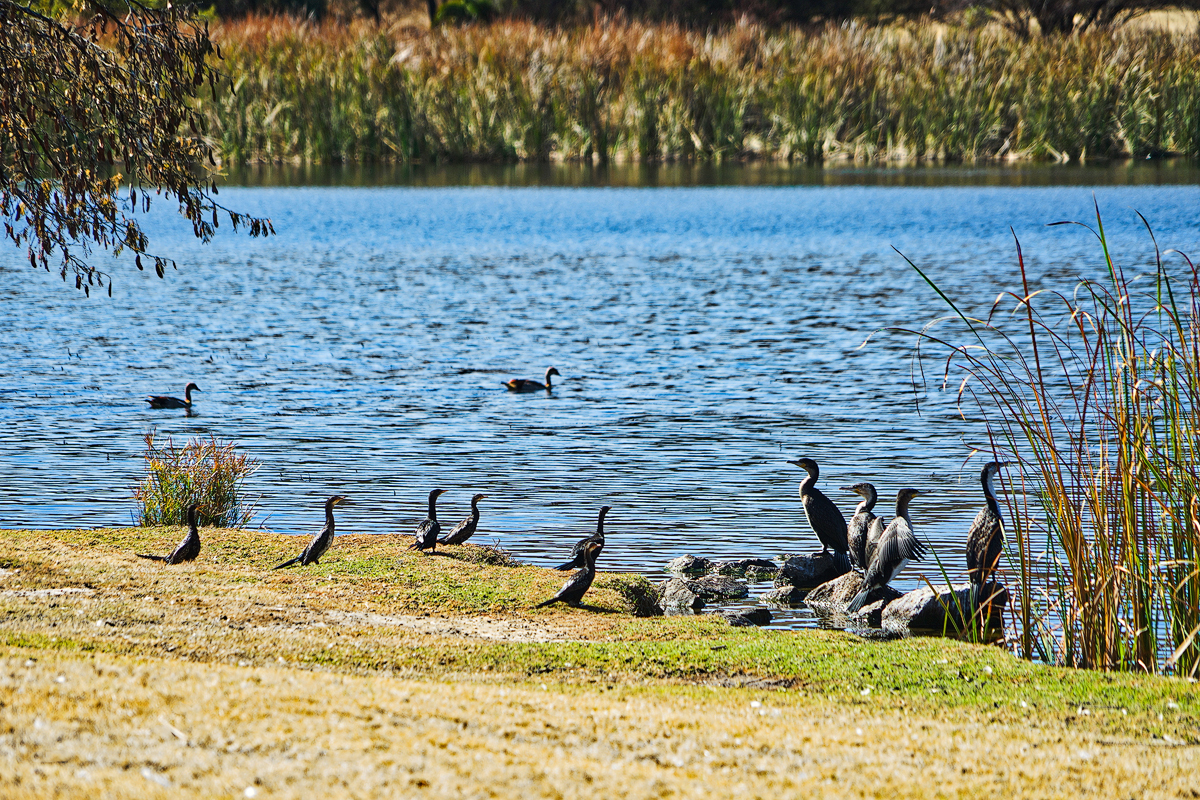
913, 207, 1200, 676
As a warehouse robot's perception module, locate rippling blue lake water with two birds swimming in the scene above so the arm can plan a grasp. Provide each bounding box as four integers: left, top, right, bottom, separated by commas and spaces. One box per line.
0, 169, 1200, 625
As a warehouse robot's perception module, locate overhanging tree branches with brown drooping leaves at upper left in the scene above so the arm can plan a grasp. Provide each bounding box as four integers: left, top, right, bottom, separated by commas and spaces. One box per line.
0, 0, 275, 295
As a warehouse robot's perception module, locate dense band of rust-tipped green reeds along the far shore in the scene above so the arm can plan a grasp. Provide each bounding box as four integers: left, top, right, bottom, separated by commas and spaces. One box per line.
204, 19, 1200, 163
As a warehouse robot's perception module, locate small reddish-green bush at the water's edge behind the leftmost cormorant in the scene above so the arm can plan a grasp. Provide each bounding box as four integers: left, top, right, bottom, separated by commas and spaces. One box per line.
133, 429, 259, 528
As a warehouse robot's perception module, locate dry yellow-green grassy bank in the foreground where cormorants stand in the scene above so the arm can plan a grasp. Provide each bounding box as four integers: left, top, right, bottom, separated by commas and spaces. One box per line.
0, 529, 1200, 798
